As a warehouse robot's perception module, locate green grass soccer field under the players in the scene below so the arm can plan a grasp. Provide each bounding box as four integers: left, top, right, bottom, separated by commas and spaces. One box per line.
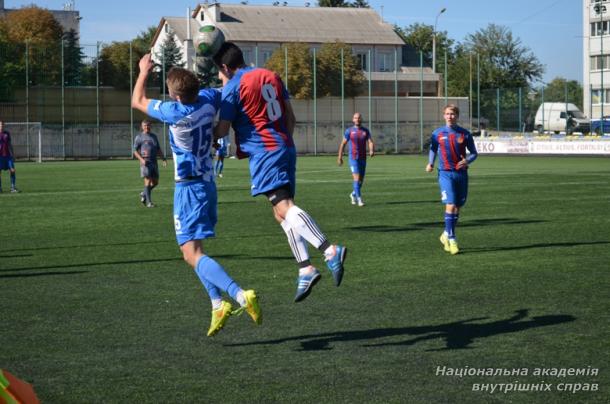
0, 156, 610, 403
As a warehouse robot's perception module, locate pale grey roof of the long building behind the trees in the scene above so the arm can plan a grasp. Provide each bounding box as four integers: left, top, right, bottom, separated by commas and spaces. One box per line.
172, 3, 404, 46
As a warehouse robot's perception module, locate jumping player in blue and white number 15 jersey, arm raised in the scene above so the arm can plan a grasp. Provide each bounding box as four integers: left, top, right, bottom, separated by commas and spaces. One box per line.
131, 54, 262, 336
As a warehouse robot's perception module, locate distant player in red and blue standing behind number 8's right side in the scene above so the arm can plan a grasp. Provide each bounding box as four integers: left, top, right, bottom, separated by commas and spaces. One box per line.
337, 112, 375, 206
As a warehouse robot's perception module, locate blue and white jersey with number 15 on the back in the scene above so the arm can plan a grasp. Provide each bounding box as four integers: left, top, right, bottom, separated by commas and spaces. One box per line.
148, 89, 220, 181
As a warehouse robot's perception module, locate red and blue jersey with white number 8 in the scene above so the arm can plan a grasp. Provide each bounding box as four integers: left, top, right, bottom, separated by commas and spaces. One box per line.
220, 67, 294, 158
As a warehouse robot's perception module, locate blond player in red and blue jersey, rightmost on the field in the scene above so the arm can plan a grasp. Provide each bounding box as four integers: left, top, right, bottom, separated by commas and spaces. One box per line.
426, 104, 478, 255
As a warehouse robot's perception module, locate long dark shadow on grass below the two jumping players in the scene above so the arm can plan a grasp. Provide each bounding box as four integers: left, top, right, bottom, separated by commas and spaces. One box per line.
226, 309, 576, 351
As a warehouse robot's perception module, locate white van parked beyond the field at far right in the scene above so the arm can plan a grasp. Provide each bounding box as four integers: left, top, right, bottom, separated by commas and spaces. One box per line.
534, 102, 590, 134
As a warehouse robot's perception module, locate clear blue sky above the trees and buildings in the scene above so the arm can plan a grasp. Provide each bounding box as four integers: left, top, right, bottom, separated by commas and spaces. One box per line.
4, 0, 583, 83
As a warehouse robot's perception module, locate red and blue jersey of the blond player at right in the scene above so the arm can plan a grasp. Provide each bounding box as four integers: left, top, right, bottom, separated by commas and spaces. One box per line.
430, 125, 471, 171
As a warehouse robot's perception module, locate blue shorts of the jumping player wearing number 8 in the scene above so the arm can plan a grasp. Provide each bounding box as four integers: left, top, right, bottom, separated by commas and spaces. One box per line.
250, 147, 297, 196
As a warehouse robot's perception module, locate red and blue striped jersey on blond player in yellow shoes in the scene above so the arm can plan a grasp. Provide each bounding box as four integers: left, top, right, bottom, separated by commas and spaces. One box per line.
428, 125, 478, 171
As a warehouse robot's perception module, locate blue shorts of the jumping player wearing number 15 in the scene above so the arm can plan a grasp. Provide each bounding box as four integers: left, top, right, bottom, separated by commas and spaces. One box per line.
174, 181, 218, 245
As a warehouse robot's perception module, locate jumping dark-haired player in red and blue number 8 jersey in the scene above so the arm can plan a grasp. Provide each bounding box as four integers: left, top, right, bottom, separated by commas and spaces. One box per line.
214, 42, 347, 302
